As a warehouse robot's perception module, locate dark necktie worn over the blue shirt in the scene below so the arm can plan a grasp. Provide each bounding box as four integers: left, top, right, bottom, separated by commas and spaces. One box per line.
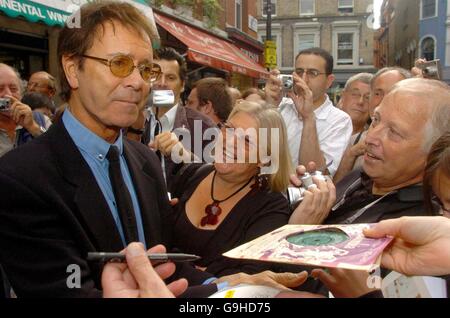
106, 146, 139, 245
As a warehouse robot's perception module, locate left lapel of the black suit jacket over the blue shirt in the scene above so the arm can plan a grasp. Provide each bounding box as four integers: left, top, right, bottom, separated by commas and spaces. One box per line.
48, 121, 123, 252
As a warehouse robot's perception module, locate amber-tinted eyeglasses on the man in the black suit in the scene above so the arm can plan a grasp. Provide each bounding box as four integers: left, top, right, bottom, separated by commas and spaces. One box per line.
82, 54, 161, 83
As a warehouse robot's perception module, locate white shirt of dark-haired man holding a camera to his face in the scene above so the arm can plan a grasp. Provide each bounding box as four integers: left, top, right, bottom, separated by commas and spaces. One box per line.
279, 96, 353, 175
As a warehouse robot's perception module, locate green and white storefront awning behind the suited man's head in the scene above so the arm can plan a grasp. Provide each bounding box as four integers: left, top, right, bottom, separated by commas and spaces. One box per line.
0, 0, 153, 26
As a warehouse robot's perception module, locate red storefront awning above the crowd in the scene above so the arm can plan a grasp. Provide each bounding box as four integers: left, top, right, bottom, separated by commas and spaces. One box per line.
154, 13, 269, 78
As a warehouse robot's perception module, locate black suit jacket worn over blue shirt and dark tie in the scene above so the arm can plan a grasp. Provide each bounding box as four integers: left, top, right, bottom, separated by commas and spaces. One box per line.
0, 121, 207, 297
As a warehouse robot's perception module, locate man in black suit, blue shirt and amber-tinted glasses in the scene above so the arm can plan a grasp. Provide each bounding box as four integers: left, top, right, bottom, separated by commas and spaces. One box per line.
0, 2, 208, 297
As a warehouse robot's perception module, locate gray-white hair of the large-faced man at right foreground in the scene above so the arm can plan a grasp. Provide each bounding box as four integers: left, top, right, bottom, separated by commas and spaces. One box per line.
391, 78, 450, 153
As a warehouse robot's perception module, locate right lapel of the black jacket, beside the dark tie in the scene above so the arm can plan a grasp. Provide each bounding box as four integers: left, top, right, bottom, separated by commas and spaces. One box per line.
123, 139, 162, 247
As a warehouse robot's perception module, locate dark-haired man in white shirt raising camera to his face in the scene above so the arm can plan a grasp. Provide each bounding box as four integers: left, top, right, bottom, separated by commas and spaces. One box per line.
266, 48, 353, 175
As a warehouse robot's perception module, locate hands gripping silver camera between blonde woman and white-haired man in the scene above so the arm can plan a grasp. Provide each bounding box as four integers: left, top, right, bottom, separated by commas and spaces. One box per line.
289, 163, 336, 225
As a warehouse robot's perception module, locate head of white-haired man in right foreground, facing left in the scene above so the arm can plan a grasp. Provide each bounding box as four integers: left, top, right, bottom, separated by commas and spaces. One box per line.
363, 79, 450, 194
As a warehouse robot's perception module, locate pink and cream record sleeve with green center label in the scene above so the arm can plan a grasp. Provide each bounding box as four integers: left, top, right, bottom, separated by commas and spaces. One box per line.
224, 224, 392, 271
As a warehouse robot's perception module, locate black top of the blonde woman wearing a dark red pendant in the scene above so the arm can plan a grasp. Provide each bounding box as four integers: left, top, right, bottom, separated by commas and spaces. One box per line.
172, 165, 290, 277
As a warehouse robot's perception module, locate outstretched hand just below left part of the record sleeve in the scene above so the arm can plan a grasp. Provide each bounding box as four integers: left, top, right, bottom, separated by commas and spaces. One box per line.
215, 271, 308, 291
